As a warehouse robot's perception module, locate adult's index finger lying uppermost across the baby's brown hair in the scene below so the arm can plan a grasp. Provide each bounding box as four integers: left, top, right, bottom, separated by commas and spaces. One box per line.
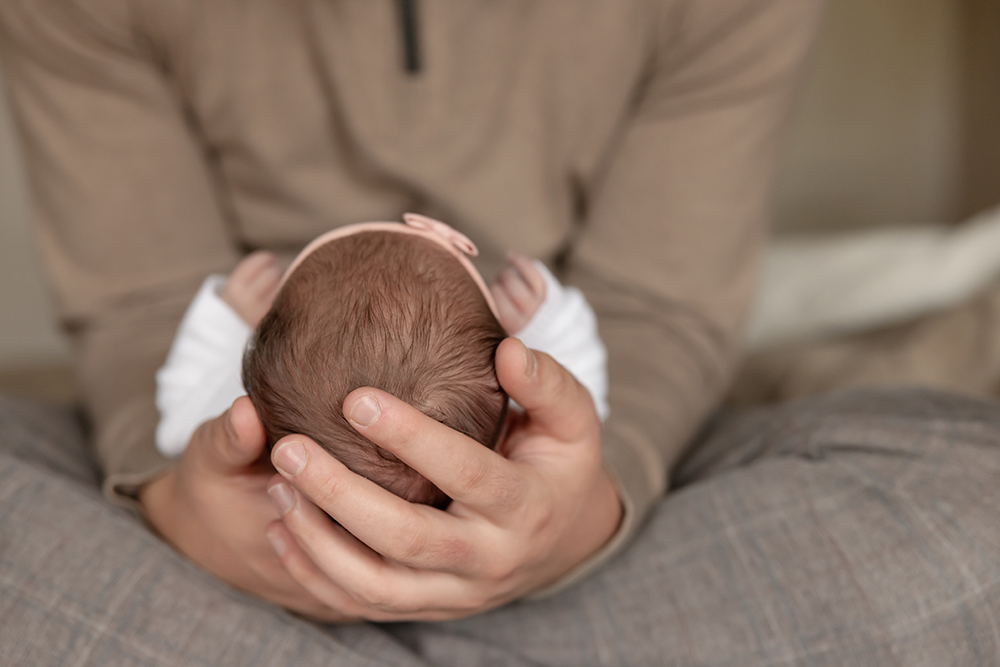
344, 388, 524, 517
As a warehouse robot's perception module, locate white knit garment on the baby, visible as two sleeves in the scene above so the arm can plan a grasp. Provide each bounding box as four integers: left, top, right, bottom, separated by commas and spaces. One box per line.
156, 262, 608, 457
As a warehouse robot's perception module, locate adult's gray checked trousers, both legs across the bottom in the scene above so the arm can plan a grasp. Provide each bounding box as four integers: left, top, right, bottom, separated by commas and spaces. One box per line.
0, 390, 1000, 667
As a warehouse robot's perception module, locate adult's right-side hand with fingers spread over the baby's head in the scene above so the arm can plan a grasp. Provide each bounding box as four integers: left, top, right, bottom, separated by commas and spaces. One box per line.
268, 339, 622, 621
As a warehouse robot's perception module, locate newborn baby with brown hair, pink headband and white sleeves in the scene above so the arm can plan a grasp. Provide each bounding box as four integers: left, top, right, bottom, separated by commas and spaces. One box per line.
157, 214, 607, 507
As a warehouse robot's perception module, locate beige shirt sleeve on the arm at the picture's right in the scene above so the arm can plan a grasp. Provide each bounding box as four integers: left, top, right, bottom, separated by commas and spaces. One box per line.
542, 0, 822, 595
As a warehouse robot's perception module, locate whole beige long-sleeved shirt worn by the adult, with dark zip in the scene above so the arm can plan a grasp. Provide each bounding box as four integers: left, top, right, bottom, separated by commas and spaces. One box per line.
0, 0, 820, 579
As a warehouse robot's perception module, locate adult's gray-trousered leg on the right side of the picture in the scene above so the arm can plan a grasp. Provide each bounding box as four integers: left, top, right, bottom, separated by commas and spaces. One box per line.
424, 390, 1000, 666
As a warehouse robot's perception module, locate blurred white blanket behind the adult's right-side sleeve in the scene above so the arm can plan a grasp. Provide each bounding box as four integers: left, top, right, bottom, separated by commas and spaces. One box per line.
745, 208, 1000, 350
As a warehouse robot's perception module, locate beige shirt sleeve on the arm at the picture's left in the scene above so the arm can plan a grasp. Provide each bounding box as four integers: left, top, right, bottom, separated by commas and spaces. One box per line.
0, 0, 237, 502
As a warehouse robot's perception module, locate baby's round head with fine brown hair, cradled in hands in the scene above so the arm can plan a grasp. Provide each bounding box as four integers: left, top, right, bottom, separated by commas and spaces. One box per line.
243, 219, 507, 507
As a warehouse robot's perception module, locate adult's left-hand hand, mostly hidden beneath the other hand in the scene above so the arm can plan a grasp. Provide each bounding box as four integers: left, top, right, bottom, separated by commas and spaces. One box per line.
139, 397, 345, 621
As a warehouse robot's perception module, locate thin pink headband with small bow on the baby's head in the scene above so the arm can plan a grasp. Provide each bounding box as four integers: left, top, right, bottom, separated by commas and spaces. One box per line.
278, 213, 500, 320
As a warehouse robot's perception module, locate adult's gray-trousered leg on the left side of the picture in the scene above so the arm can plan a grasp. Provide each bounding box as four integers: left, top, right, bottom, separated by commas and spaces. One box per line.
0, 398, 420, 666
